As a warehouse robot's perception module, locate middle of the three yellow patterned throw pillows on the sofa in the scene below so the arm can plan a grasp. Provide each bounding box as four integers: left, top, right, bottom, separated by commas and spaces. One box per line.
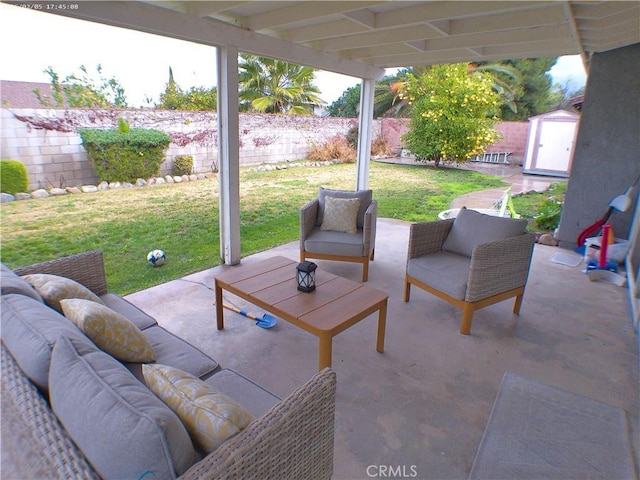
60, 298, 156, 363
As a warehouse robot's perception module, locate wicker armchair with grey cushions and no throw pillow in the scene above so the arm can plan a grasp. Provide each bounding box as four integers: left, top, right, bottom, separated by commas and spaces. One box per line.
404, 211, 535, 335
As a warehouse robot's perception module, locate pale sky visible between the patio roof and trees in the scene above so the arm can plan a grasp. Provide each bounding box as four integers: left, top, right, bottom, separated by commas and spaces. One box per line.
0, 3, 586, 107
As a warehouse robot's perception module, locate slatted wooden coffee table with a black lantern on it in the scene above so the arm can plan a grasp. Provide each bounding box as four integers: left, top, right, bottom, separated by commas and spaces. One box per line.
215, 257, 389, 370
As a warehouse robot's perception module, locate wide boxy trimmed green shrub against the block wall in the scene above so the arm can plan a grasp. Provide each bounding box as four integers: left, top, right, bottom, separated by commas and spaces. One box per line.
79, 125, 171, 182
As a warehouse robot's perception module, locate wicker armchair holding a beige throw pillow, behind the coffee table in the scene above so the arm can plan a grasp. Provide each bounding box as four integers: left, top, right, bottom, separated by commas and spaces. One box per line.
300, 188, 378, 282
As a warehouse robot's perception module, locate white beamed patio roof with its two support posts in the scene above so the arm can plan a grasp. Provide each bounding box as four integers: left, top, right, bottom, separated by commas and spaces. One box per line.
22, 0, 640, 264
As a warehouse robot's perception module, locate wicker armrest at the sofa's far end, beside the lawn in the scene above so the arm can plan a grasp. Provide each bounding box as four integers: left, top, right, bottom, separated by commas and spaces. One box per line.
14, 250, 108, 296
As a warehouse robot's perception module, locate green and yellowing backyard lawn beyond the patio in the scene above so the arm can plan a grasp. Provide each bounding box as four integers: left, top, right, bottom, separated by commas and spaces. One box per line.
0, 162, 505, 295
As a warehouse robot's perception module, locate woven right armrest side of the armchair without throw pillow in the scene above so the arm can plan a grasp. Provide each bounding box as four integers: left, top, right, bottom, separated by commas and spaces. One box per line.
465, 233, 536, 302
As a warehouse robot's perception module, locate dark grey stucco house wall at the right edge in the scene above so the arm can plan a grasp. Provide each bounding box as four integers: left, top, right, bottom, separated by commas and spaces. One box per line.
558, 44, 640, 258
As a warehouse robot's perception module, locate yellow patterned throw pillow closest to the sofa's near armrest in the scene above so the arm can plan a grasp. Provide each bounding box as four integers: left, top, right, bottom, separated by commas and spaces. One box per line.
142, 364, 253, 453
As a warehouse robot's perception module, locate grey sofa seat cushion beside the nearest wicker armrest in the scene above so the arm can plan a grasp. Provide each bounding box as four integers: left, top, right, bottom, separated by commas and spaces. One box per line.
206, 368, 282, 418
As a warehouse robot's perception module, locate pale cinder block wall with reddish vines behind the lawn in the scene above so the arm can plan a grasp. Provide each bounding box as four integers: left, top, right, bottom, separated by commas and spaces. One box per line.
0, 108, 526, 190
